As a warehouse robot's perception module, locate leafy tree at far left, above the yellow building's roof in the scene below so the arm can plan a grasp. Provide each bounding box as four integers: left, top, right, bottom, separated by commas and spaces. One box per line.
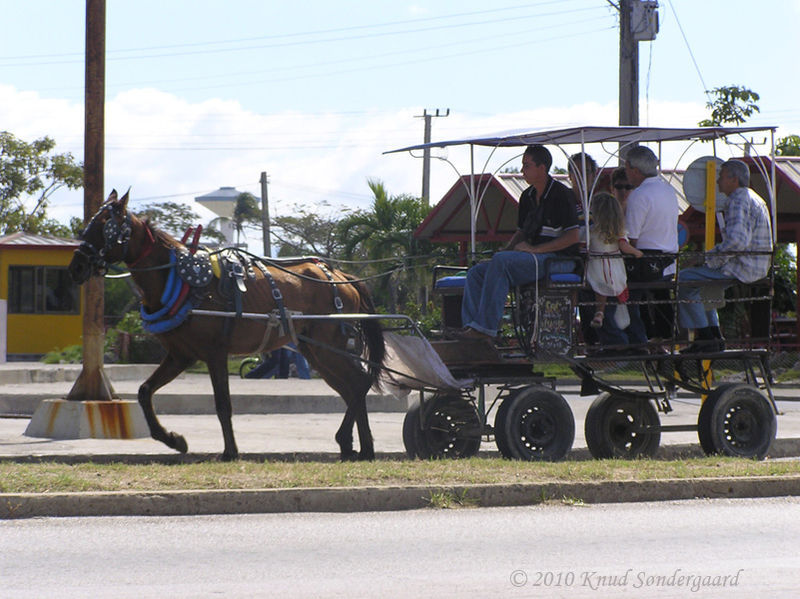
0, 131, 83, 236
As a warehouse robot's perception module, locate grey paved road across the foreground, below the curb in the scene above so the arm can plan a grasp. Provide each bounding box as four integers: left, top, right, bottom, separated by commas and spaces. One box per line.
0, 498, 800, 599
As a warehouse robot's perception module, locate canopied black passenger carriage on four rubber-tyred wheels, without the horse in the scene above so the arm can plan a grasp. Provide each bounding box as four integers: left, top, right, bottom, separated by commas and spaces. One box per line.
388, 127, 777, 460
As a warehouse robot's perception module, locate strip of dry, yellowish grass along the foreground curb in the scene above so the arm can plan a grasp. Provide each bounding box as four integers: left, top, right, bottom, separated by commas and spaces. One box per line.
0, 457, 800, 494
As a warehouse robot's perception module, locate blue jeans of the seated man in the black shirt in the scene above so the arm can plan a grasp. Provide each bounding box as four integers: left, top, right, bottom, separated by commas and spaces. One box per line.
461, 251, 575, 337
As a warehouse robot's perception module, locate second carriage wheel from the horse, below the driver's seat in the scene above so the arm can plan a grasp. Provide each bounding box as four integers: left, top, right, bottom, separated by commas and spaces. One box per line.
495, 386, 575, 461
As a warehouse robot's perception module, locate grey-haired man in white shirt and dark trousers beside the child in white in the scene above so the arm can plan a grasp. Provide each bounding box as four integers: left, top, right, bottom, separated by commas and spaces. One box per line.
625, 146, 679, 350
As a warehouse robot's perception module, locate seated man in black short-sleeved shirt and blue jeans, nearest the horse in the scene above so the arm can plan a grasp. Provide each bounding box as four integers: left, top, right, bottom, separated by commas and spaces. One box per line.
461, 145, 579, 338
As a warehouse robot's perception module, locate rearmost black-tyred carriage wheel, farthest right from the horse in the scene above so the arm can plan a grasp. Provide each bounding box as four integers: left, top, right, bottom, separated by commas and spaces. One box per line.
697, 383, 778, 460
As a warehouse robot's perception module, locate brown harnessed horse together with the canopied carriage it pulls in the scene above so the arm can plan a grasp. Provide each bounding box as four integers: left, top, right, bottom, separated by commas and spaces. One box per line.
70, 127, 777, 460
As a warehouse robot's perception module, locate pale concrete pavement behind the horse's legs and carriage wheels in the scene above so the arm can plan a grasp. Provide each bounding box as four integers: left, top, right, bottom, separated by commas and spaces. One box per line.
0, 364, 800, 460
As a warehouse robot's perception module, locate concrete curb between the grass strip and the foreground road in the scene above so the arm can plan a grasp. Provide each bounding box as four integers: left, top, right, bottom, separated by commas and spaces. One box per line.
0, 476, 800, 519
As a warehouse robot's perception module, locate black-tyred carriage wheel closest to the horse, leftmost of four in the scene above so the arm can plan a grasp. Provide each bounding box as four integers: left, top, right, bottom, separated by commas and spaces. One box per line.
403, 394, 483, 459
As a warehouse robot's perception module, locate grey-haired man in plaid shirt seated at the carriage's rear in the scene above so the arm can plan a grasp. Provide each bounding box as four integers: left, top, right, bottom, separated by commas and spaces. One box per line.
678, 160, 772, 353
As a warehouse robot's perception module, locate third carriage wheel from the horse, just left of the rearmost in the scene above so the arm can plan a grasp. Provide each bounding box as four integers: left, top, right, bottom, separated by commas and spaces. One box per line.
584, 393, 661, 458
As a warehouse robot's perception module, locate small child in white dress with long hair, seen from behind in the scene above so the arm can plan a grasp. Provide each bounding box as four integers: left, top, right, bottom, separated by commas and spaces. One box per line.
586, 193, 644, 329
